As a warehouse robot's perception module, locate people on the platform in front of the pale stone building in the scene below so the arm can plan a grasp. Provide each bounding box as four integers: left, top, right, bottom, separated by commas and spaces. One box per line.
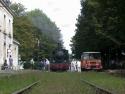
2, 55, 13, 70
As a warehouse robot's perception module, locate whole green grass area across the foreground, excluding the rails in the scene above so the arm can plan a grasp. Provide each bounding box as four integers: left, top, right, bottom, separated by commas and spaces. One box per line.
0, 71, 125, 94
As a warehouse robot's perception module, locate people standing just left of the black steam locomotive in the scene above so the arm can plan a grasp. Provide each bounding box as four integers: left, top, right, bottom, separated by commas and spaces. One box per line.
40, 58, 50, 71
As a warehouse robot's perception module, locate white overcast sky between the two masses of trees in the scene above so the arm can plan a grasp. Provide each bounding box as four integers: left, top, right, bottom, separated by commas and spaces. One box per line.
11, 0, 81, 52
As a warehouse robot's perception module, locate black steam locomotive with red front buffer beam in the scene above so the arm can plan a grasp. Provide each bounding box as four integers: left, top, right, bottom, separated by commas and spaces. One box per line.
50, 48, 69, 71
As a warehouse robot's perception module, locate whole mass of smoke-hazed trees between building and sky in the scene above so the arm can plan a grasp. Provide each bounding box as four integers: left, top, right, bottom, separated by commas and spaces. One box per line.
11, 3, 61, 61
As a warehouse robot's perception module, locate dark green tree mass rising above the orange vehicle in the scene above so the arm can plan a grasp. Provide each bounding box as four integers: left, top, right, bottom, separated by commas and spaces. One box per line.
72, 0, 125, 58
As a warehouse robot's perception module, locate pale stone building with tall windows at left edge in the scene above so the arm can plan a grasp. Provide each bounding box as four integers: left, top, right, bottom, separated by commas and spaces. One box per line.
0, 0, 19, 69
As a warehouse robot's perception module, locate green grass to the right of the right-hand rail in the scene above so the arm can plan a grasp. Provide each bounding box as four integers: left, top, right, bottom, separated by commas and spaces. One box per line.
82, 72, 125, 94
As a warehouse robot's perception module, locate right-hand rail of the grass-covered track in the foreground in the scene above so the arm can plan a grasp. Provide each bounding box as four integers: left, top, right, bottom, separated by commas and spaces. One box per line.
81, 80, 116, 94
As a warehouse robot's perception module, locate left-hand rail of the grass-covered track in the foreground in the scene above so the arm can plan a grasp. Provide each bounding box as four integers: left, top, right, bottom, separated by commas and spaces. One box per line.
12, 81, 39, 94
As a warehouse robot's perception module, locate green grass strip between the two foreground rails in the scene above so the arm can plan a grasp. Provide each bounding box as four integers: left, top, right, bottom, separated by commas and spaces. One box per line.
26, 72, 94, 94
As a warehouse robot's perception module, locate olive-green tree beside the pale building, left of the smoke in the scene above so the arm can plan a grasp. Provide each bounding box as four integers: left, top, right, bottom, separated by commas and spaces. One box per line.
13, 16, 38, 60
